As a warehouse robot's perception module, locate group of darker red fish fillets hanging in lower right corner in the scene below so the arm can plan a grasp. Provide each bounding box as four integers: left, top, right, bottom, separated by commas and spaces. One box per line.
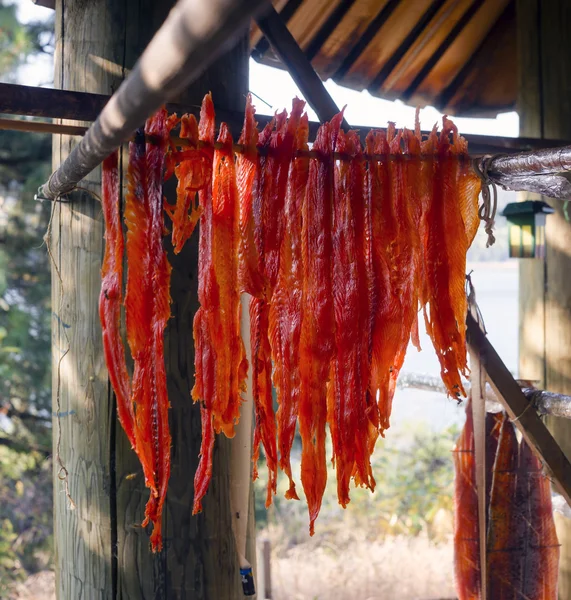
454, 405, 559, 600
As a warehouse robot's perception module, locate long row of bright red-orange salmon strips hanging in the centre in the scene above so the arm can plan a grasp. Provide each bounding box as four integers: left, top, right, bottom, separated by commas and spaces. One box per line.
100, 95, 480, 549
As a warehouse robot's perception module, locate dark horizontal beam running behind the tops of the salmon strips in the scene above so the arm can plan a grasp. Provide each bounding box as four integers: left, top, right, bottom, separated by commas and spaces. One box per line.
0, 83, 569, 155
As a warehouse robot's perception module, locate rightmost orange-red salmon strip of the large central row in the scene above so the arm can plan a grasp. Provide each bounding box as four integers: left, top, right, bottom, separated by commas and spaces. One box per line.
424, 117, 480, 397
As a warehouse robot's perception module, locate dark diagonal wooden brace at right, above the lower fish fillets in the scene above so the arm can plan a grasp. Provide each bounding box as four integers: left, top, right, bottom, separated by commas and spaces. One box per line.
467, 314, 571, 506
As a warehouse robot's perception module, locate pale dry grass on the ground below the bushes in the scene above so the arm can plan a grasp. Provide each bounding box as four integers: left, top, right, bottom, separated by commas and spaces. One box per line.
258, 530, 455, 600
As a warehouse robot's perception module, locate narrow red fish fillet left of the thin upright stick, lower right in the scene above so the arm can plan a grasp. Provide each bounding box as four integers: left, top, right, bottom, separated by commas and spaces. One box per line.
453, 403, 481, 600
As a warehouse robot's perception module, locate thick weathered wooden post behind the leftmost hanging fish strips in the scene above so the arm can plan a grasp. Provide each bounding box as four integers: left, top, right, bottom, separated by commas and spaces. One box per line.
50, 0, 254, 600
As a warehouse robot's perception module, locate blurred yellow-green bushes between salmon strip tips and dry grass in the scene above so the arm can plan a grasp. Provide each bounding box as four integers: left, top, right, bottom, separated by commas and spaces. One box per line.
255, 426, 458, 547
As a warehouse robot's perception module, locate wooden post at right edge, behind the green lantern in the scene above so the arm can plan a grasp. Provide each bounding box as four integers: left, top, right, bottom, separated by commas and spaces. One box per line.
517, 0, 571, 599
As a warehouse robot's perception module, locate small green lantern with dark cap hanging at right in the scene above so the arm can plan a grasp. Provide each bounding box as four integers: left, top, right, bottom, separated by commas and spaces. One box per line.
502, 200, 554, 258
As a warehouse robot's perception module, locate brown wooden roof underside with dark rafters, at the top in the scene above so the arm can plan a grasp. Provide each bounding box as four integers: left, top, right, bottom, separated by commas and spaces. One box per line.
250, 0, 517, 116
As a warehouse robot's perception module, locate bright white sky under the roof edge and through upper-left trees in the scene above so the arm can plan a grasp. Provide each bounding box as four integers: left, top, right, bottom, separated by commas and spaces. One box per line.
16, 0, 519, 137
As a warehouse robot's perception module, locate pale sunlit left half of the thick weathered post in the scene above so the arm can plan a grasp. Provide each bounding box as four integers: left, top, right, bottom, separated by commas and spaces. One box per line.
52, 0, 126, 599
